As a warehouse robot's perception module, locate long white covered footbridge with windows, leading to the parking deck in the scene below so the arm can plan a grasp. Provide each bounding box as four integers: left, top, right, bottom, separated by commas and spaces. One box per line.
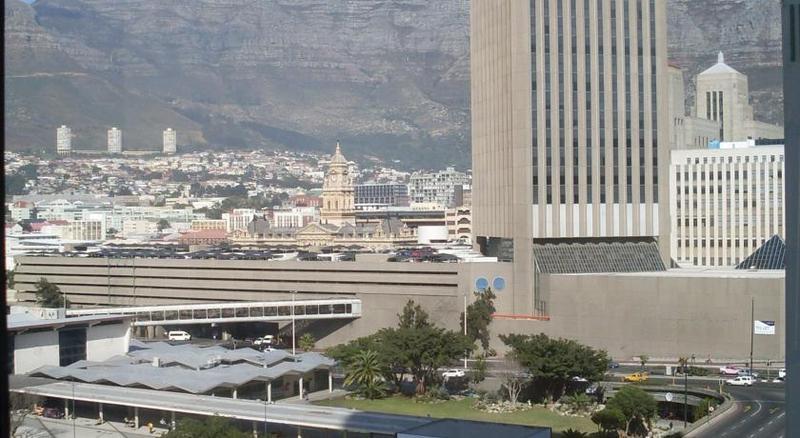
67, 298, 361, 326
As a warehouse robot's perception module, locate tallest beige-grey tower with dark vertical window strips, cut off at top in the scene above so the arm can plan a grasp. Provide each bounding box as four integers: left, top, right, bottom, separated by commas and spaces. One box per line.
470, 0, 669, 311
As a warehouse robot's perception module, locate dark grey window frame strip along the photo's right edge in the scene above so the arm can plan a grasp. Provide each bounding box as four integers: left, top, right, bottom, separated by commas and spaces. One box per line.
783, 0, 800, 437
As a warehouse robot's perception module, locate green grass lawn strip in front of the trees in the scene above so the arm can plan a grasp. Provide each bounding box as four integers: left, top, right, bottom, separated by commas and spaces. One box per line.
316, 396, 597, 432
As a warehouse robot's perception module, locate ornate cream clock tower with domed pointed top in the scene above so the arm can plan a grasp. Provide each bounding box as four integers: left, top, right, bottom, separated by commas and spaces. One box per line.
320, 141, 356, 226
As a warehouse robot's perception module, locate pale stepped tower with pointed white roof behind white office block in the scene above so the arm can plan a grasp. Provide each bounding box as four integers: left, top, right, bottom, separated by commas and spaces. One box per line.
695, 52, 783, 141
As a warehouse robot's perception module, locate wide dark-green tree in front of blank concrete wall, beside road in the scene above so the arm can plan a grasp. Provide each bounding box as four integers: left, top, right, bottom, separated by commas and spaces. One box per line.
500, 333, 609, 400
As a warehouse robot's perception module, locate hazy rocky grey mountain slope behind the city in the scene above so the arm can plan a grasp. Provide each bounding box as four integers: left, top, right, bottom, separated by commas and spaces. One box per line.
5, 0, 781, 168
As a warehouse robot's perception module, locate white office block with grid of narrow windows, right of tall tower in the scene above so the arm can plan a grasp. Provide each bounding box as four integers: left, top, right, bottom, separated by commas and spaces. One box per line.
670, 144, 787, 266
